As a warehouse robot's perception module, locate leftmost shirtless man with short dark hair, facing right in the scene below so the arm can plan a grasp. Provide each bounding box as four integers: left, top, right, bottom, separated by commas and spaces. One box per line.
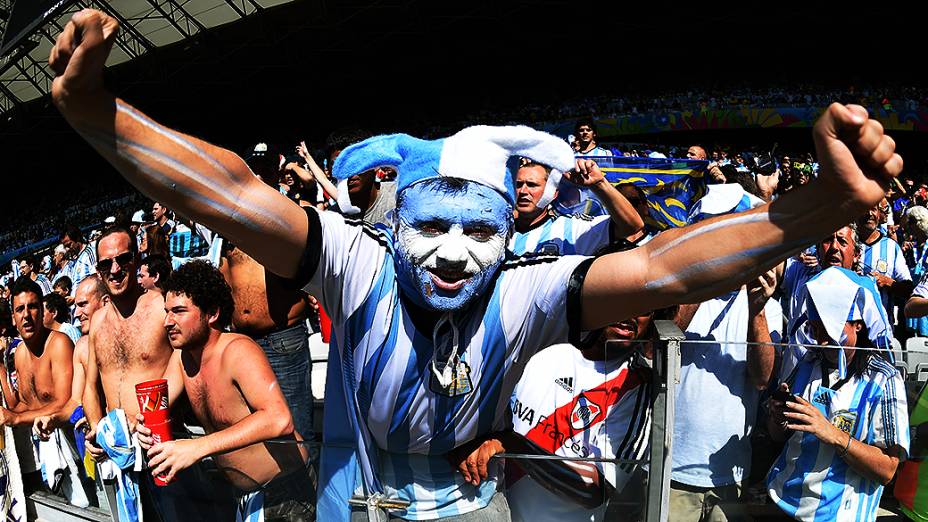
0, 277, 74, 426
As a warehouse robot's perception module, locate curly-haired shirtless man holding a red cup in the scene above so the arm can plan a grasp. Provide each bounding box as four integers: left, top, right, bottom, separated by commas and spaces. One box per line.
137, 261, 316, 521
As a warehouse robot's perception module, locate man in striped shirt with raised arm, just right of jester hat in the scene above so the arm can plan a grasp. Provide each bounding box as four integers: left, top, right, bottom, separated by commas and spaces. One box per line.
509, 159, 644, 255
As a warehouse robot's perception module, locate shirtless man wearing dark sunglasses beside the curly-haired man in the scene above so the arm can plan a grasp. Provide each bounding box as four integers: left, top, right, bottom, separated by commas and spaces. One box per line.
83, 227, 172, 457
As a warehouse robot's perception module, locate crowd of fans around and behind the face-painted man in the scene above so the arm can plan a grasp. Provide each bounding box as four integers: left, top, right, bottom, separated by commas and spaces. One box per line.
0, 110, 928, 520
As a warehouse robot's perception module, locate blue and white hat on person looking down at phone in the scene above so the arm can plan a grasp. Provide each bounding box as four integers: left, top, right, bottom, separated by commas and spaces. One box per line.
790, 266, 892, 378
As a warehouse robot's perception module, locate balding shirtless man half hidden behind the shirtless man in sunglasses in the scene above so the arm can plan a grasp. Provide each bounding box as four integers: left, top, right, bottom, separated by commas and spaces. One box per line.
33, 276, 109, 439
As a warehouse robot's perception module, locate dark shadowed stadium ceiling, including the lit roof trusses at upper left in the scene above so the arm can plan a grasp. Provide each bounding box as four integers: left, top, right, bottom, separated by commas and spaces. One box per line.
0, 0, 921, 175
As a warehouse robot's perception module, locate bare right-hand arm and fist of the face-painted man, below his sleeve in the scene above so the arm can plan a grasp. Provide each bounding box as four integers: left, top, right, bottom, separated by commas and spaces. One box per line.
582, 104, 902, 330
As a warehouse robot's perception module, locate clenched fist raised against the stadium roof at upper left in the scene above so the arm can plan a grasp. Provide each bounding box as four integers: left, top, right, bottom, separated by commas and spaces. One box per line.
48, 9, 119, 115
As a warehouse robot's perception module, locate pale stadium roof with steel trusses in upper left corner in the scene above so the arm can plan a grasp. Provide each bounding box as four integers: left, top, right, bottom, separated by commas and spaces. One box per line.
0, 0, 291, 114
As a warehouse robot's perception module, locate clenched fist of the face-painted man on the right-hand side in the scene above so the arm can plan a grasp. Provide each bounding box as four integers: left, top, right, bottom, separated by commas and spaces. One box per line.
813, 103, 902, 212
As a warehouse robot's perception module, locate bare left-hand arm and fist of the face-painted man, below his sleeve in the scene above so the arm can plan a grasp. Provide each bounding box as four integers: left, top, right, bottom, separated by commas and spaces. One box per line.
49, 9, 307, 277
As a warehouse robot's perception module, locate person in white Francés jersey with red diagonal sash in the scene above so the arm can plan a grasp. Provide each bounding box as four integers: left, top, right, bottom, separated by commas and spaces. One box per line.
490, 306, 654, 522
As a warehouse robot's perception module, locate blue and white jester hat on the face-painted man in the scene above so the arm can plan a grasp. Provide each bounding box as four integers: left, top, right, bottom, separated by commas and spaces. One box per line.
332, 125, 574, 214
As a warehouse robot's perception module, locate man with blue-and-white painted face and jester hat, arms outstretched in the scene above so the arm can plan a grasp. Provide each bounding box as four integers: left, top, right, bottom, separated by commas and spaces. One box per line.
50, 10, 902, 521
